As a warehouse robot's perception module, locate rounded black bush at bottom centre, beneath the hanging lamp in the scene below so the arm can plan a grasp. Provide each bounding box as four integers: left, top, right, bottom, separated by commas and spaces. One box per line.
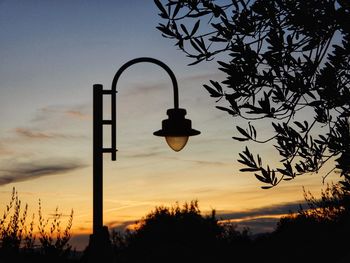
113, 201, 221, 262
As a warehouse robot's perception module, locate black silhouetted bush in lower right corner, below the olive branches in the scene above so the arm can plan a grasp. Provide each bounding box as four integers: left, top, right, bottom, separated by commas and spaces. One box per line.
270, 185, 350, 262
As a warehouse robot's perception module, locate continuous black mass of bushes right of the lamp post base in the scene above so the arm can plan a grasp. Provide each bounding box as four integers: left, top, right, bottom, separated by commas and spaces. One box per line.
112, 185, 350, 263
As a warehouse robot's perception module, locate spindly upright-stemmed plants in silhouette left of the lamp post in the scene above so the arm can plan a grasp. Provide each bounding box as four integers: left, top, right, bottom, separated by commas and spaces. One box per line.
0, 188, 73, 262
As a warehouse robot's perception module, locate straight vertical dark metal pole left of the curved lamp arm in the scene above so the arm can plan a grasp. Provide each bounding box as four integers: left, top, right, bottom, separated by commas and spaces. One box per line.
93, 84, 103, 234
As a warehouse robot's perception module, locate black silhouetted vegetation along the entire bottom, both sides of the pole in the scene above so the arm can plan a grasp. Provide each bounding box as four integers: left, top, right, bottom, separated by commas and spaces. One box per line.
0, 185, 350, 263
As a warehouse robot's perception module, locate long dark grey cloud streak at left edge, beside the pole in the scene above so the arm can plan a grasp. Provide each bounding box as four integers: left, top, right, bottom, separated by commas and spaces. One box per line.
0, 160, 87, 186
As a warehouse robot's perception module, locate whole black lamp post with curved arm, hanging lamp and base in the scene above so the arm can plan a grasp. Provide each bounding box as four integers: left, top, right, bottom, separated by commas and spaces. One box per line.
88, 57, 200, 262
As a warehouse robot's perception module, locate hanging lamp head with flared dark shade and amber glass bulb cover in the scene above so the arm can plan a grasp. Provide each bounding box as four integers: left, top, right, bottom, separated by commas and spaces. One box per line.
153, 108, 200, 152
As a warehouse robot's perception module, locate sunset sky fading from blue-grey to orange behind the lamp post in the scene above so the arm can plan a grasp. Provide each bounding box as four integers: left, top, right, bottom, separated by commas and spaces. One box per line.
0, 0, 337, 252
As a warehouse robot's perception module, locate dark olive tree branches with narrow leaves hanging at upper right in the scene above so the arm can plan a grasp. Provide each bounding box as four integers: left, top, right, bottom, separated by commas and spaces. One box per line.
155, 0, 350, 189
